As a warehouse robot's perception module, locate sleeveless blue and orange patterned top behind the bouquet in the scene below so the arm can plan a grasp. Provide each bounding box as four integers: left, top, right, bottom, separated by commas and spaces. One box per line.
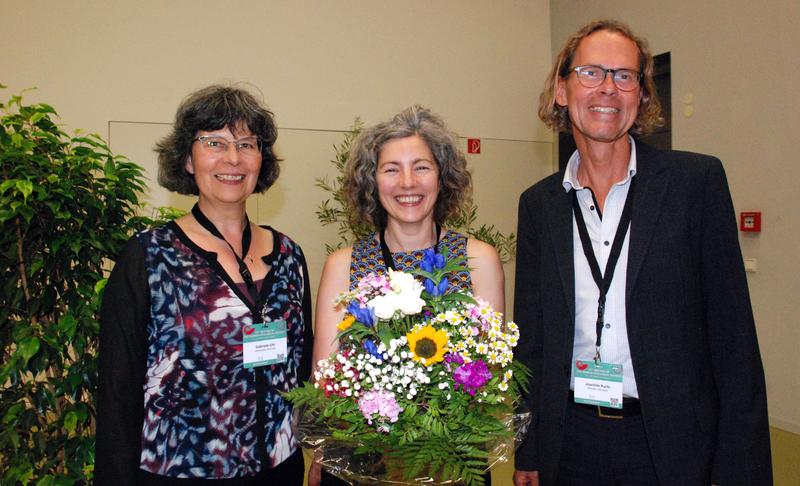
350, 231, 472, 293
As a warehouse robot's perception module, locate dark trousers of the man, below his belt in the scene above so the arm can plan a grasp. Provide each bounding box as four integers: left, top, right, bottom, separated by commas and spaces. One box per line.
556, 403, 658, 486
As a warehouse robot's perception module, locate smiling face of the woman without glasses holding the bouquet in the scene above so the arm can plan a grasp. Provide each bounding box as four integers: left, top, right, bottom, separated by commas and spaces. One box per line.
376, 135, 439, 231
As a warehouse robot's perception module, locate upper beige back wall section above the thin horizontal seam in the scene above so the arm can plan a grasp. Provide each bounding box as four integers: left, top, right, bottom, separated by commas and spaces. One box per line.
0, 0, 550, 140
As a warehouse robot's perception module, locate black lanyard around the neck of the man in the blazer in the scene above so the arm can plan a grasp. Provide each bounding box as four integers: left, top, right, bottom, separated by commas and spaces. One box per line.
572, 179, 636, 362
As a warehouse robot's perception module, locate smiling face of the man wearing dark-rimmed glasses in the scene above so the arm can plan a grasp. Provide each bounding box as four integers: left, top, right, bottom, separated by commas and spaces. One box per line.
556, 30, 642, 147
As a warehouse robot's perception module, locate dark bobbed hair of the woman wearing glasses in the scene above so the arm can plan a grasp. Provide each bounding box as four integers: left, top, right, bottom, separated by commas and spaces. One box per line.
155, 85, 281, 195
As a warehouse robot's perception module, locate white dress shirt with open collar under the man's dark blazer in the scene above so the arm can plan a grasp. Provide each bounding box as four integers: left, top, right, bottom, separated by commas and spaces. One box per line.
563, 138, 639, 398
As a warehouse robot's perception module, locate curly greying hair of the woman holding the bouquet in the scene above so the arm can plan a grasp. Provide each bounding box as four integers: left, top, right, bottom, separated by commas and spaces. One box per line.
343, 105, 472, 228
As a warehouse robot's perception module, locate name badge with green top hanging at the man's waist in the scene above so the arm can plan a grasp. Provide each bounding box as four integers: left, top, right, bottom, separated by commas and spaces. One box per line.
575, 359, 622, 408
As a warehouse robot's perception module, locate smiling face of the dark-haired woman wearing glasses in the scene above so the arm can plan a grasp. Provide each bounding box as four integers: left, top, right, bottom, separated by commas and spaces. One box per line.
186, 125, 261, 204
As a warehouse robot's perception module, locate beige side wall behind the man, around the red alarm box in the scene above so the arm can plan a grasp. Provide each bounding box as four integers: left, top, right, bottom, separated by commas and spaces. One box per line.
551, 0, 800, 433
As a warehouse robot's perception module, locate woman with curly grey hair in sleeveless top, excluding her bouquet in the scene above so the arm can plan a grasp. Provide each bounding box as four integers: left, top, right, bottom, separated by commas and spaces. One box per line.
308, 106, 505, 486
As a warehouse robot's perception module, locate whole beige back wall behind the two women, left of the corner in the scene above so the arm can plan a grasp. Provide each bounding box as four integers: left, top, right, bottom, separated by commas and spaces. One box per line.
0, 0, 553, 330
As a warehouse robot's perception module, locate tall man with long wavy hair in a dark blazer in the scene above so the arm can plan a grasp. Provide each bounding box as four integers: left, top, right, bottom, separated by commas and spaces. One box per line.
514, 20, 772, 486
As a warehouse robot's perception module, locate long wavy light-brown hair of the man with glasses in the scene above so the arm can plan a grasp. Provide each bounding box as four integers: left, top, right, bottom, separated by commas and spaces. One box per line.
539, 19, 664, 135
